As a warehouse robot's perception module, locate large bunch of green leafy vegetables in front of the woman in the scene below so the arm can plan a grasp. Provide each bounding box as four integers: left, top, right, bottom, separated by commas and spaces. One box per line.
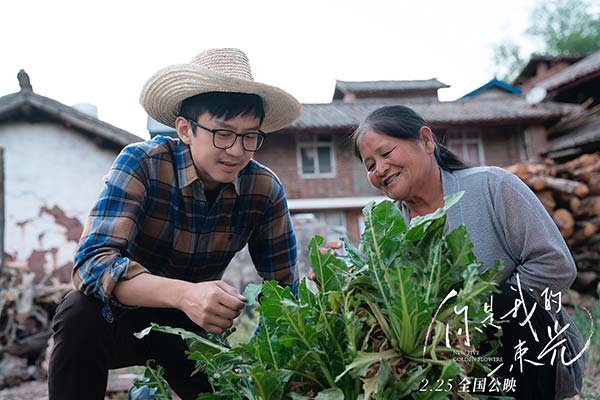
135, 193, 501, 400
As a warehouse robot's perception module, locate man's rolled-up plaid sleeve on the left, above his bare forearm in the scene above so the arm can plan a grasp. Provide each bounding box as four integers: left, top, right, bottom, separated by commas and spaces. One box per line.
73, 146, 147, 304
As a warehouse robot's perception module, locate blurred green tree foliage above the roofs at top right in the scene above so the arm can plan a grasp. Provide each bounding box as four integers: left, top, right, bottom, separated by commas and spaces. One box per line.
494, 0, 600, 81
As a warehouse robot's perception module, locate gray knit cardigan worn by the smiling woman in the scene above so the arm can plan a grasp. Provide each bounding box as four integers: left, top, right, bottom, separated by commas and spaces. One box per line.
399, 167, 584, 399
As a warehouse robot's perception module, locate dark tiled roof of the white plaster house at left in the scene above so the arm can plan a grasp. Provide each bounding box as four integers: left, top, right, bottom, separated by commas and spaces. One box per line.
0, 72, 143, 147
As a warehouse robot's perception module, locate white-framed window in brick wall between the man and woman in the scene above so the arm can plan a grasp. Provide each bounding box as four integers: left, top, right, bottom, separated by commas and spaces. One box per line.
298, 135, 336, 178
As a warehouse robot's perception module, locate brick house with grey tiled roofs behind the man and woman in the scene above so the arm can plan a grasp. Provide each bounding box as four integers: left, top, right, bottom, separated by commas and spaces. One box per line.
148, 79, 576, 245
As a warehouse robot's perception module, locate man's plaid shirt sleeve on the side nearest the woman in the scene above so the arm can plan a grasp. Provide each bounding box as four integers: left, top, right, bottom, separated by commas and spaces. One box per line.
248, 182, 298, 293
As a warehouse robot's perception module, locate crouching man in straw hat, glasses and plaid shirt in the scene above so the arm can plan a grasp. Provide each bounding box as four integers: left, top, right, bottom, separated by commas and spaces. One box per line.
48, 49, 302, 399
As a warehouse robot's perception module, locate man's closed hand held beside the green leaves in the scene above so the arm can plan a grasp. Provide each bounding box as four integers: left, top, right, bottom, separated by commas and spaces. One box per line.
177, 281, 246, 334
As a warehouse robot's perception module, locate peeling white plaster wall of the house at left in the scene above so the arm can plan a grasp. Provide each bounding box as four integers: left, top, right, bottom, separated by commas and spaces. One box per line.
0, 123, 123, 280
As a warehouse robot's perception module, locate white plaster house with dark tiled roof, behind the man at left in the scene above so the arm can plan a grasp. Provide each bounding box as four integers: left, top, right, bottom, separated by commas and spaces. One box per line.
0, 71, 141, 282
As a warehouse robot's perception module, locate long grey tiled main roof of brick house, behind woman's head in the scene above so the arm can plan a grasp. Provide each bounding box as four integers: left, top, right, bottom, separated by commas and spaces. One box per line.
288, 99, 579, 130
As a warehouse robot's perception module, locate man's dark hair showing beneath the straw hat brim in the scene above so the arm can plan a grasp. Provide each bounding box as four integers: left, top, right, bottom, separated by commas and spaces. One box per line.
179, 92, 265, 128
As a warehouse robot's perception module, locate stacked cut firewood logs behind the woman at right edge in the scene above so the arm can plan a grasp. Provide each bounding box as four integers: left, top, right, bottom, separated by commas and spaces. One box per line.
507, 153, 600, 293
